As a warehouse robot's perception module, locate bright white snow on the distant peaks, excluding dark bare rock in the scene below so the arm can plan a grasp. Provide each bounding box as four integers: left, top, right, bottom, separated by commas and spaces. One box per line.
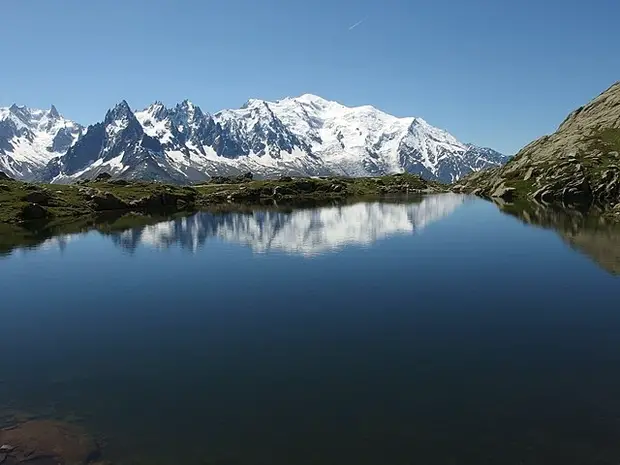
0, 94, 506, 180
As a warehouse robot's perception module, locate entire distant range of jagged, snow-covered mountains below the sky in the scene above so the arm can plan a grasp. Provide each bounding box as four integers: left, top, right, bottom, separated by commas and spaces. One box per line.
0, 94, 507, 183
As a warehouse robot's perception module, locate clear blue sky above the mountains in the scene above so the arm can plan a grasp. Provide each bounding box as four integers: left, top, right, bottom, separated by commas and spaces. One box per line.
0, 0, 620, 154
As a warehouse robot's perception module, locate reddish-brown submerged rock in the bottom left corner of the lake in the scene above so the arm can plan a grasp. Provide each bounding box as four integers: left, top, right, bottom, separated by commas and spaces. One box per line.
0, 420, 101, 465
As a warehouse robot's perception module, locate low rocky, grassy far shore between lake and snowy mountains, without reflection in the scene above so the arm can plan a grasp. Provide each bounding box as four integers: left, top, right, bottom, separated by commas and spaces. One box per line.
0, 174, 448, 225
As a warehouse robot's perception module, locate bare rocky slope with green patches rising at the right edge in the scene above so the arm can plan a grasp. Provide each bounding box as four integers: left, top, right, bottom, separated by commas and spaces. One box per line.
454, 82, 620, 206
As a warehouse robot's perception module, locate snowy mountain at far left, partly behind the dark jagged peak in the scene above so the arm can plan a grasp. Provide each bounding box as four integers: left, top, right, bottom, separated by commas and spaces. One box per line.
0, 105, 83, 180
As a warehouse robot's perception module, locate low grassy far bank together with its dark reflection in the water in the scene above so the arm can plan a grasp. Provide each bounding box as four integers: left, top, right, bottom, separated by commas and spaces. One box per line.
0, 174, 447, 255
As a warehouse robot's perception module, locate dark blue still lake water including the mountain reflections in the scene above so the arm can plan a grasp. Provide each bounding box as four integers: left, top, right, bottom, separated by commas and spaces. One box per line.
0, 195, 620, 465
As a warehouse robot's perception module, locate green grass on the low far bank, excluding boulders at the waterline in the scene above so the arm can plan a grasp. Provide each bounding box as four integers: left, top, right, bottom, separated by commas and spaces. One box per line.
0, 174, 448, 224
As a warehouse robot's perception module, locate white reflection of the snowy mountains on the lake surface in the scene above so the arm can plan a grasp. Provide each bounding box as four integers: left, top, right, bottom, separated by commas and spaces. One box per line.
105, 194, 467, 256
